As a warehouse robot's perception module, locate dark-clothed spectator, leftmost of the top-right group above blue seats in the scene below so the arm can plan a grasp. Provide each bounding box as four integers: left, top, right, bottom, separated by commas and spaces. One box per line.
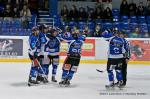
120, 0, 129, 15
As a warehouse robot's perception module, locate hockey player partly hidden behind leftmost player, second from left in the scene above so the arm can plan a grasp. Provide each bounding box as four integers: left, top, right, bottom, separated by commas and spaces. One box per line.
36, 24, 49, 83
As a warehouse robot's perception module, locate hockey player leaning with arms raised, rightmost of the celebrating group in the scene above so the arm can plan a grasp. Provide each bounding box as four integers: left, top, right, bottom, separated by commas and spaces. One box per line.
59, 28, 86, 86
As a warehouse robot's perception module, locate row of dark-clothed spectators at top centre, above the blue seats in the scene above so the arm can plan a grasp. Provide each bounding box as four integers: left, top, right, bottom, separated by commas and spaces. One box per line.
61, 0, 112, 21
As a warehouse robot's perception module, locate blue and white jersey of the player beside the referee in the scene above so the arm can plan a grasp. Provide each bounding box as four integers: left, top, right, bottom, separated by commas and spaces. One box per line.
108, 36, 126, 58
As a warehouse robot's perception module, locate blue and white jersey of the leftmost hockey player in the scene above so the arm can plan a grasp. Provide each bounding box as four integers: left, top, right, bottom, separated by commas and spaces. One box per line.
28, 34, 38, 55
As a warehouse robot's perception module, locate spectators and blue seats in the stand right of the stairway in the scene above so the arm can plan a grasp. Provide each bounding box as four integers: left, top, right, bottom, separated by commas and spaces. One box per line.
60, 0, 150, 38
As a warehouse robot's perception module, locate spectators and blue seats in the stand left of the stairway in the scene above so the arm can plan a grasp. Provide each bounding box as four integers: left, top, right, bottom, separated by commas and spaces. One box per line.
0, 0, 38, 35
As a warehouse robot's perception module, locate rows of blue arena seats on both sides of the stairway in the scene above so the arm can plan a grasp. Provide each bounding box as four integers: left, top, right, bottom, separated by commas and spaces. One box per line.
0, 9, 150, 36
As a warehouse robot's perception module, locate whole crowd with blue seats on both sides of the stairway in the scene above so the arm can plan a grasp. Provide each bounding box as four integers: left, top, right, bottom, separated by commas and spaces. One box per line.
0, 0, 150, 38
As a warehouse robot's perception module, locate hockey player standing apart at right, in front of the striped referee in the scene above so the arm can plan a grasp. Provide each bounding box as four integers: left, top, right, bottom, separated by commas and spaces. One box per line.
102, 29, 126, 88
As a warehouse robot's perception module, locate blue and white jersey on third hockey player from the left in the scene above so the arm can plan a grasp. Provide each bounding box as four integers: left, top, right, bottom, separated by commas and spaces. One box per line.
44, 36, 60, 56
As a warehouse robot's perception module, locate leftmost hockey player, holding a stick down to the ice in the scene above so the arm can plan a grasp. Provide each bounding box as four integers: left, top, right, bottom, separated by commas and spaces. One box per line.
28, 27, 39, 85
